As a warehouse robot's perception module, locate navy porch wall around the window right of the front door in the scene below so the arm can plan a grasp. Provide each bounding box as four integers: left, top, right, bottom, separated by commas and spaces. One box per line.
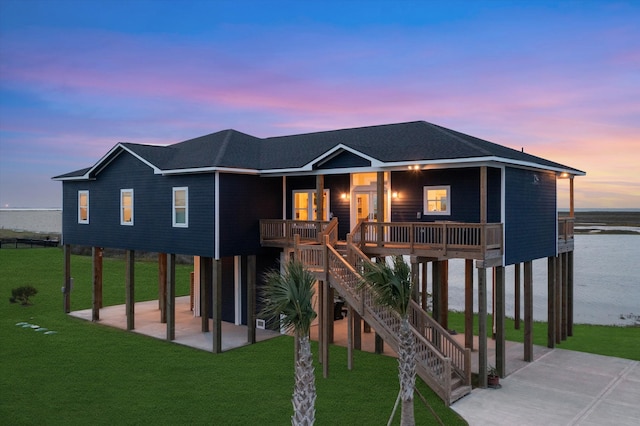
391, 167, 501, 223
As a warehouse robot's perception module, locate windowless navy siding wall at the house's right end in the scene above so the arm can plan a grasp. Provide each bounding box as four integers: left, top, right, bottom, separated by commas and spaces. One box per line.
505, 168, 558, 265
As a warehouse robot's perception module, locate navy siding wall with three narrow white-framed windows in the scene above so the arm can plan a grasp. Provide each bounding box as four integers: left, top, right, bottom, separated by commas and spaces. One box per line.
62, 151, 214, 257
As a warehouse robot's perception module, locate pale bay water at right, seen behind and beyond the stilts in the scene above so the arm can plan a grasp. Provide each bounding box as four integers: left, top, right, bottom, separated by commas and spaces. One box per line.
440, 235, 640, 325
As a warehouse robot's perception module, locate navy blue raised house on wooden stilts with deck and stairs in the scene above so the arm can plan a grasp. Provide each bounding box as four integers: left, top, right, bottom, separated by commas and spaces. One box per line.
53, 121, 585, 404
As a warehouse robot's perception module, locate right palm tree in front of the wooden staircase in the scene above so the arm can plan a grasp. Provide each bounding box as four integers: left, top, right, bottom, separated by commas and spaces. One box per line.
362, 256, 416, 426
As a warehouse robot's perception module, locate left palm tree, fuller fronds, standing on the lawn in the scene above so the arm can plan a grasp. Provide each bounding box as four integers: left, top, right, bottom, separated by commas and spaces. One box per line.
261, 260, 316, 426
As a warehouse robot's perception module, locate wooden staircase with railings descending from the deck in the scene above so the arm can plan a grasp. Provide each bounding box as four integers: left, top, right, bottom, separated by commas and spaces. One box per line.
294, 230, 471, 405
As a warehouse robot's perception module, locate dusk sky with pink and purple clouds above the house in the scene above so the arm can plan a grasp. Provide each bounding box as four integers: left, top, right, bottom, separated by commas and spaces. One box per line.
0, 0, 640, 208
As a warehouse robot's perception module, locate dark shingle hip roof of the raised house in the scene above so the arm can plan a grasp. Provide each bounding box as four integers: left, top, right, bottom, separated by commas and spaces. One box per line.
54, 121, 584, 179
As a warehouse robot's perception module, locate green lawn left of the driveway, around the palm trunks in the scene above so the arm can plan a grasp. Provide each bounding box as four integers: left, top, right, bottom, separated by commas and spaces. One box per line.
0, 249, 466, 425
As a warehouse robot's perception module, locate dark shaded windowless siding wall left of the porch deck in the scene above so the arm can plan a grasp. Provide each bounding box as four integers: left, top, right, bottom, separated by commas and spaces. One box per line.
219, 173, 282, 257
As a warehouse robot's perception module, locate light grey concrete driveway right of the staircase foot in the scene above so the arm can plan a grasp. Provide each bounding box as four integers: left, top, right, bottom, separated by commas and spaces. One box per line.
452, 349, 640, 426
